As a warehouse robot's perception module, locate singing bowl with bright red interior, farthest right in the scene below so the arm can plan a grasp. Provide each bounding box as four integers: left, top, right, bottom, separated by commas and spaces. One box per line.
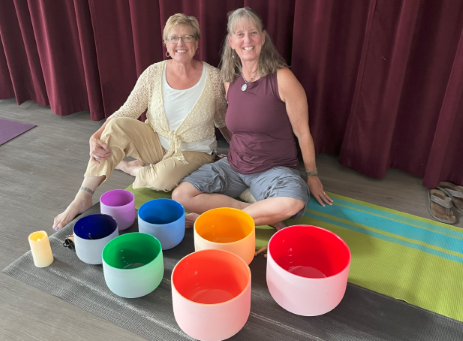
267, 225, 351, 316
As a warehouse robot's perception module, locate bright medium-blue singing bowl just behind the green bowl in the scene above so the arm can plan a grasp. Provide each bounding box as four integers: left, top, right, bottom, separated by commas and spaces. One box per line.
138, 199, 185, 250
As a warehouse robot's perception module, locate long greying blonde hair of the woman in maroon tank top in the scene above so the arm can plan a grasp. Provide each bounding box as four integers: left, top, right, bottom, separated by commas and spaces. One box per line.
220, 7, 288, 83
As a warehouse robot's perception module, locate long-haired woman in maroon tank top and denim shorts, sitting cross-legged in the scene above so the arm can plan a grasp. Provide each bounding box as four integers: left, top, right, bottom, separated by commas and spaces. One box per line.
173, 8, 332, 234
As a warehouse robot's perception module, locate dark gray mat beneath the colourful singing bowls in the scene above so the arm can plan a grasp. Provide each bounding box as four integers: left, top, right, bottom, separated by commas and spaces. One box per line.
3, 204, 463, 341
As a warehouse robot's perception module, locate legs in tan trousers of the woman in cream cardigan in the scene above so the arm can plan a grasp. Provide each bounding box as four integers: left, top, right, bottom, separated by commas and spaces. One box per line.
53, 118, 213, 230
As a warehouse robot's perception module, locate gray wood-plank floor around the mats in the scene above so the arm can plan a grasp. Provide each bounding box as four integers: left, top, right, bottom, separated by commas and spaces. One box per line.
0, 99, 463, 340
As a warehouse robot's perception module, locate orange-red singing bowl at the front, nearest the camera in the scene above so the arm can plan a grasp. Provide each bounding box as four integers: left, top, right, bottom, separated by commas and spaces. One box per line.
172, 250, 251, 341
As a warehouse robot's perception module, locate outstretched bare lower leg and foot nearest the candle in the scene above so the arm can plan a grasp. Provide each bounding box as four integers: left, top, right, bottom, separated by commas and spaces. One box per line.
53, 175, 105, 231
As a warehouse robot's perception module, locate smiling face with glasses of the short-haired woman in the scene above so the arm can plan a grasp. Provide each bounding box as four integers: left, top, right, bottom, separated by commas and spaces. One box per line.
165, 25, 198, 63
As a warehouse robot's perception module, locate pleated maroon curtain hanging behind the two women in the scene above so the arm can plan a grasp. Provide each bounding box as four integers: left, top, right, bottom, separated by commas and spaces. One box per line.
0, 0, 463, 187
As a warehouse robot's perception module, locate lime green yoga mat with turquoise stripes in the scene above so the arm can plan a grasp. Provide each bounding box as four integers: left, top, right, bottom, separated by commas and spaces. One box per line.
127, 186, 463, 321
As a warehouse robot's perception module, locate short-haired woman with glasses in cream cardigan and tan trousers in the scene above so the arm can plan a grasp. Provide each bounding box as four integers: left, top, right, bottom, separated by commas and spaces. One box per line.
53, 14, 229, 230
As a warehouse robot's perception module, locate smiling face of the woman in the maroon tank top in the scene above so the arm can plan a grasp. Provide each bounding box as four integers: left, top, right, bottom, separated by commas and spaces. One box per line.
228, 19, 265, 62
